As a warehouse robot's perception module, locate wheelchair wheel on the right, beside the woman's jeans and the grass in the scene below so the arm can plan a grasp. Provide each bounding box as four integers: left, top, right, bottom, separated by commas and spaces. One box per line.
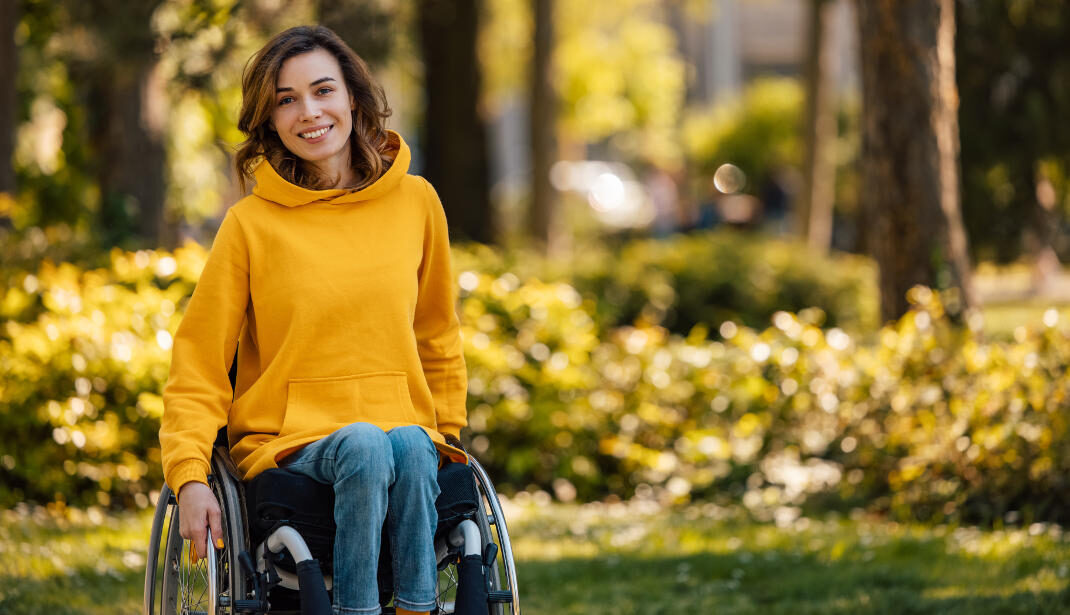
438, 458, 520, 615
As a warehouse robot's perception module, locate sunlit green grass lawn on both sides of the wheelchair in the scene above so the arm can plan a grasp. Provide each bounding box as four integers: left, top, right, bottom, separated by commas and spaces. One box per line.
0, 497, 1070, 615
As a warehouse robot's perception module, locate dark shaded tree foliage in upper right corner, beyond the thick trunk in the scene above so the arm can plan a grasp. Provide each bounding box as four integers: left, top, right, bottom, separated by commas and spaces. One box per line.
956, 0, 1070, 281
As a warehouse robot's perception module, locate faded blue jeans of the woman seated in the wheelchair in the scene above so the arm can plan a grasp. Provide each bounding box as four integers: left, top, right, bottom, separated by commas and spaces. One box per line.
282, 422, 439, 615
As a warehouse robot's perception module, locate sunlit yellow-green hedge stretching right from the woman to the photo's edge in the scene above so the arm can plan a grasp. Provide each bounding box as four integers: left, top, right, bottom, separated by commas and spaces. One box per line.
461, 272, 1070, 523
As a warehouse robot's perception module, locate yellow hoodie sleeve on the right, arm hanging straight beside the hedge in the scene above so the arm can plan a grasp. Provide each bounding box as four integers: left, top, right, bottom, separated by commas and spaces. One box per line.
413, 180, 468, 436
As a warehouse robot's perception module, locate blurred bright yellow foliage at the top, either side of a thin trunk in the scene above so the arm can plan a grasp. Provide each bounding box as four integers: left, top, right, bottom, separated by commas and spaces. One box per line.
479, 0, 686, 166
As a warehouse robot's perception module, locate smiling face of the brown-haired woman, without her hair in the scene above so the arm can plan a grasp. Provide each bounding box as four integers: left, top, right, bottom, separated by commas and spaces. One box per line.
271, 49, 354, 173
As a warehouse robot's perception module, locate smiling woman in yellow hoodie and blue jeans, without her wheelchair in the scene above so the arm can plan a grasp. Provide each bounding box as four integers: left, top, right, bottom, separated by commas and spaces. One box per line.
159, 27, 467, 614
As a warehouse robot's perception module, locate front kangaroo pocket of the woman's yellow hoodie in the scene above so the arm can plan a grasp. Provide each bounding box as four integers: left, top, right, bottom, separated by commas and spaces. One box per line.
278, 371, 416, 435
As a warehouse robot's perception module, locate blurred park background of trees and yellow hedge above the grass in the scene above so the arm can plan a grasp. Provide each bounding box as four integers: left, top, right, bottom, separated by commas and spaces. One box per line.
0, 0, 1070, 532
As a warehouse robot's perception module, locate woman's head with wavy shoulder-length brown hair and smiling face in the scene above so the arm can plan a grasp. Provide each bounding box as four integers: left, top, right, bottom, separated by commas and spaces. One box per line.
234, 27, 397, 189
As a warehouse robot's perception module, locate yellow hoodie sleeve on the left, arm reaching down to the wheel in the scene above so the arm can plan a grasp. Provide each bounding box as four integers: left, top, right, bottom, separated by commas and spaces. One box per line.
159, 211, 249, 493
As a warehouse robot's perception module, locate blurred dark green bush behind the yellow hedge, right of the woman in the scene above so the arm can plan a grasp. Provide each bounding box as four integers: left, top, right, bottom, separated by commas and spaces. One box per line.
454, 231, 877, 335
